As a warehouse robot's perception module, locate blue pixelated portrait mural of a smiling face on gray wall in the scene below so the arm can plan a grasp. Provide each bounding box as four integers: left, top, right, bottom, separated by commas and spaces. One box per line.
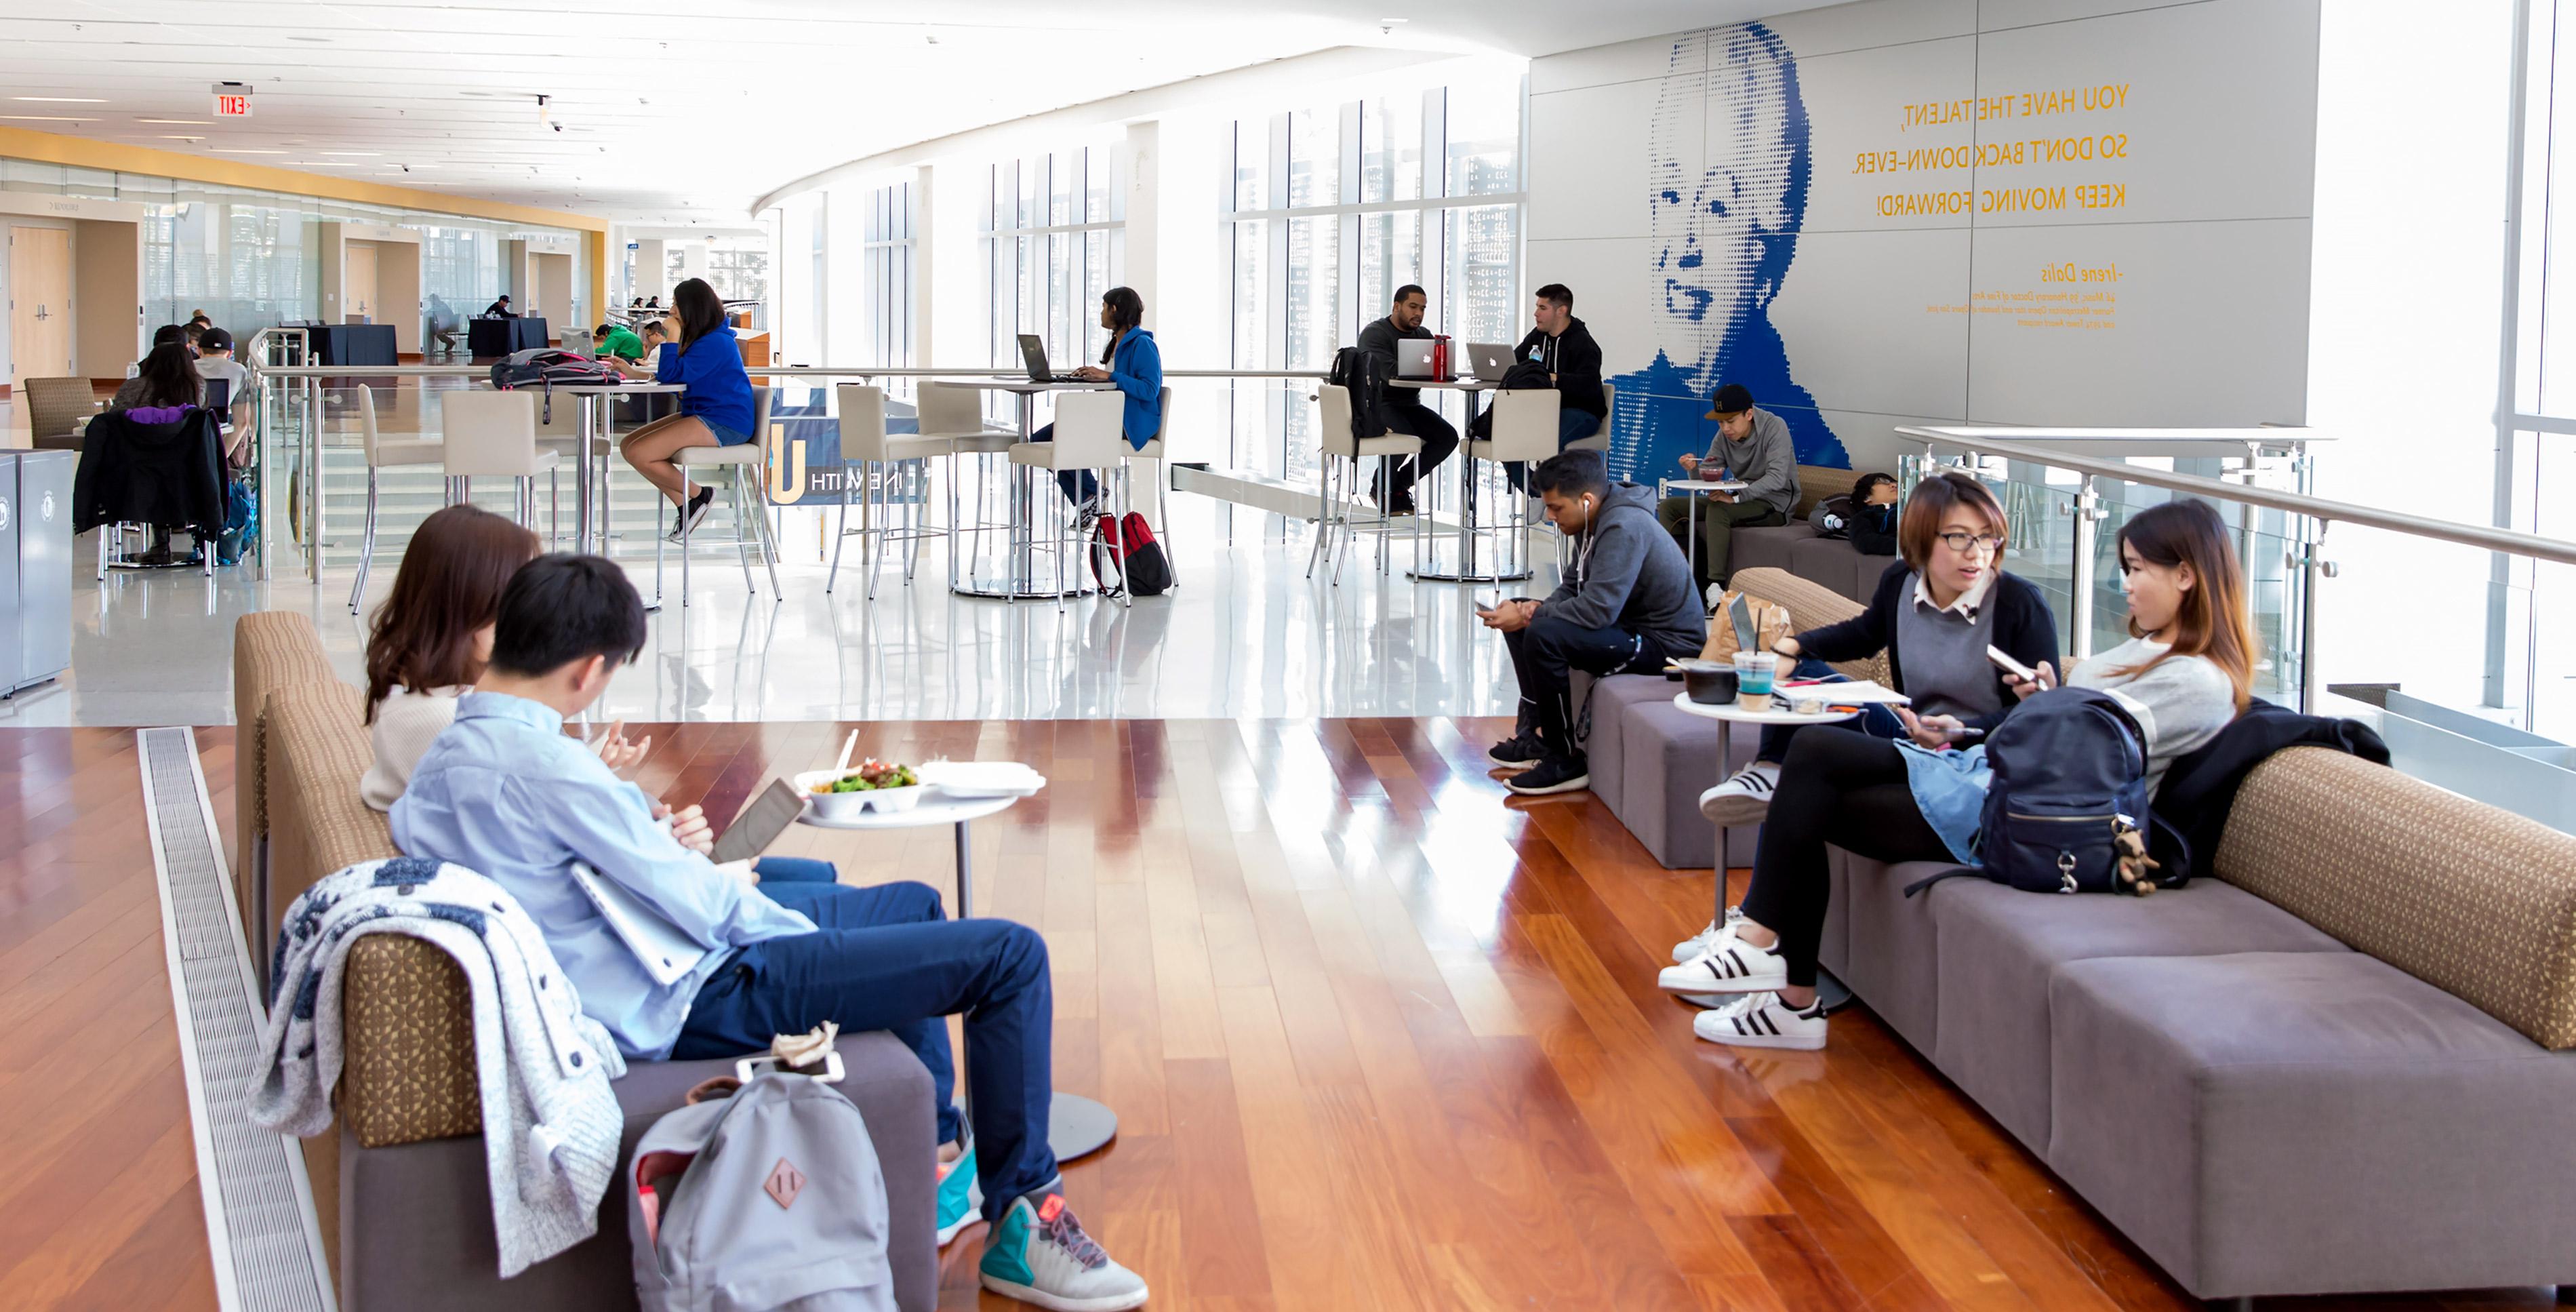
1610, 23, 1852, 482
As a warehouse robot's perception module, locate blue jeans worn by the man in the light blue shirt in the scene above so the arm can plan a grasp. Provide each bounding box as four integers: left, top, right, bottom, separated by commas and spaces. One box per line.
672, 876, 1056, 1222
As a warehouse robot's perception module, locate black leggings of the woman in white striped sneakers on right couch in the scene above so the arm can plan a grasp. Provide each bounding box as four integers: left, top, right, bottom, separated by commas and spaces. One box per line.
1744, 724, 1950, 987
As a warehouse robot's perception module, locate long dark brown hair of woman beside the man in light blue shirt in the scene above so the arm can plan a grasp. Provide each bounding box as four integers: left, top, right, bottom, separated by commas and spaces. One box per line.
366, 505, 538, 724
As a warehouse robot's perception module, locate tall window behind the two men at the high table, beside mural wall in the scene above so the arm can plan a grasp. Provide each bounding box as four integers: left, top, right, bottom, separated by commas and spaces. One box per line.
1226, 77, 1525, 479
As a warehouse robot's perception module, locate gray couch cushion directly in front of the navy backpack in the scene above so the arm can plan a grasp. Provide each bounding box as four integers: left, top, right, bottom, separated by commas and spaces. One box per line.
1927, 879, 2347, 1152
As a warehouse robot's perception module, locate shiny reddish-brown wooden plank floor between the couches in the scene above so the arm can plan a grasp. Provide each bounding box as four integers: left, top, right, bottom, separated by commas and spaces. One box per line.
0, 719, 2550, 1312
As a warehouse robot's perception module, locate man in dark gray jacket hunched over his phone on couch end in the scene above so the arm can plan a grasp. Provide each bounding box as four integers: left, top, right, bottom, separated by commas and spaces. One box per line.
1476, 451, 1706, 794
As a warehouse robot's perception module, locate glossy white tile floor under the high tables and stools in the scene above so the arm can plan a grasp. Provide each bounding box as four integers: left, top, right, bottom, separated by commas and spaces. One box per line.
0, 498, 1553, 727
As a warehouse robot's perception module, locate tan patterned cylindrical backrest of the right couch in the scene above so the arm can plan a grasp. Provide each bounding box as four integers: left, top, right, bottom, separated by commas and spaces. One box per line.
2213, 747, 2576, 1049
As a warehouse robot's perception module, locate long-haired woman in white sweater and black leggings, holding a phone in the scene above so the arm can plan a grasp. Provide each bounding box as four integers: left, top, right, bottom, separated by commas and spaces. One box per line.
1659, 500, 2257, 1049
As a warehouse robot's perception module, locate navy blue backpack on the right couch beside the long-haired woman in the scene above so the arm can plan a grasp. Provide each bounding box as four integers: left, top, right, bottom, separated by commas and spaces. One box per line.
1906, 688, 2158, 897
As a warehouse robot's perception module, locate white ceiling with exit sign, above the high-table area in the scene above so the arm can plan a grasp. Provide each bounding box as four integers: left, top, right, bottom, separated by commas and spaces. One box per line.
0, 0, 1816, 227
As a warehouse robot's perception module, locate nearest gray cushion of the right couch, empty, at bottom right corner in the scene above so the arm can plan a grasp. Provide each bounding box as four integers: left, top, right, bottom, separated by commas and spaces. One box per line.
2048, 948, 2576, 1299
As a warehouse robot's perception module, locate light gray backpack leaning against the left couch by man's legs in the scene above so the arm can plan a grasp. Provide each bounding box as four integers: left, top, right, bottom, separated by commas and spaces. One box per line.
626, 1072, 894, 1312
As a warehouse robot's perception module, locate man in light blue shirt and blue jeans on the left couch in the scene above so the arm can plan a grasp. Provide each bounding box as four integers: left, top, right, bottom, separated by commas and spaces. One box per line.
392, 554, 1146, 1312
